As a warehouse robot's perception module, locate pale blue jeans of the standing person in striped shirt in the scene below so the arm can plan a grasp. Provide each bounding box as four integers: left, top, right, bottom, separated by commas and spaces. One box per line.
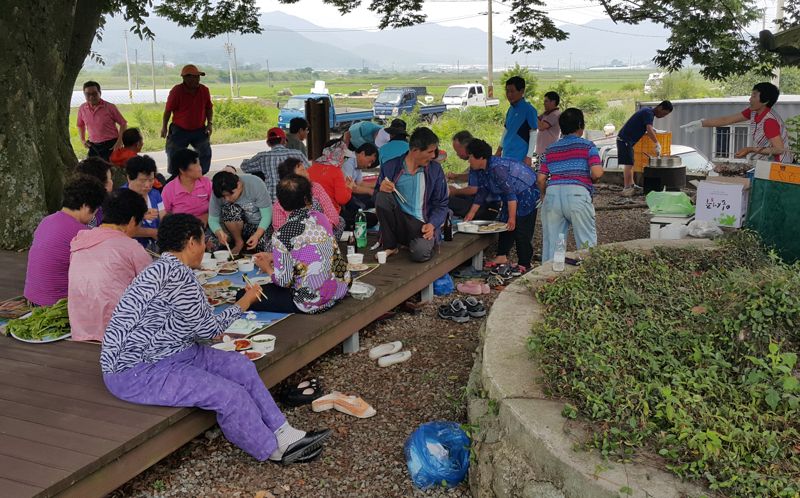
540, 185, 597, 263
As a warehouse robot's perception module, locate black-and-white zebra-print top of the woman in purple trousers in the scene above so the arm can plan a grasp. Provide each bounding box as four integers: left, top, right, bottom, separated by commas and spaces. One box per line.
100, 253, 242, 373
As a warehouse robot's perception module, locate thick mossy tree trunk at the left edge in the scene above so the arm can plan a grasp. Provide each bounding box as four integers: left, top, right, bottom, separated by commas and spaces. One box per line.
0, 0, 105, 249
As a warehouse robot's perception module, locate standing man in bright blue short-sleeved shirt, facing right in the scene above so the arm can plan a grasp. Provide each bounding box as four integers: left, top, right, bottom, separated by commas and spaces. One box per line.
495, 76, 539, 166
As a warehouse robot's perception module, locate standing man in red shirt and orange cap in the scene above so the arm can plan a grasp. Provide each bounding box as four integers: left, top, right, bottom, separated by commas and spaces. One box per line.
161, 64, 214, 175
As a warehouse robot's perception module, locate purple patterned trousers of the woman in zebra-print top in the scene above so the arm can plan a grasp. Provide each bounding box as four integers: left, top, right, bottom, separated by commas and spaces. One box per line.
103, 344, 286, 461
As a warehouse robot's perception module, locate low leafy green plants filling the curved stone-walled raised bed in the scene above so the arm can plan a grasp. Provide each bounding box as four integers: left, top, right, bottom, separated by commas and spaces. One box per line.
528, 232, 800, 497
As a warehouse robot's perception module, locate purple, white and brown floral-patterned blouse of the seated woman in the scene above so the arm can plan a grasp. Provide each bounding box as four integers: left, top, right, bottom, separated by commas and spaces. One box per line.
272, 208, 350, 313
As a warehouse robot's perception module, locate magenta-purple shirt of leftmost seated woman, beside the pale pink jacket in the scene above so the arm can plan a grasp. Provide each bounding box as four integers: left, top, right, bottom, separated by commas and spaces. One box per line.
24, 211, 89, 306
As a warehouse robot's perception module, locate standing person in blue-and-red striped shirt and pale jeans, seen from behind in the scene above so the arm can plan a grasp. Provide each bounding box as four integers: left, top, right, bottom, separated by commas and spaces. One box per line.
536, 107, 603, 263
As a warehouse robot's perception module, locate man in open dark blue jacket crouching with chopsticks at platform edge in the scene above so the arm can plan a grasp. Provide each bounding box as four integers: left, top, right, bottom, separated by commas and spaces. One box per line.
375, 127, 448, 262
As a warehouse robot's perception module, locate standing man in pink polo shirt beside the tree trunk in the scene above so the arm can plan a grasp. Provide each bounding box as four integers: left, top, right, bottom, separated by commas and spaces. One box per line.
78, 81, 128, 161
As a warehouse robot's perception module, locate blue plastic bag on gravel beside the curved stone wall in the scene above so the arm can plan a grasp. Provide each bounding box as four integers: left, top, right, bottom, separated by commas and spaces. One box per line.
403, 420, 470, 489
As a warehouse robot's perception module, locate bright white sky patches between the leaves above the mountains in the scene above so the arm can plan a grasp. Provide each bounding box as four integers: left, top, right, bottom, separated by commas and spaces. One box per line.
257, 0, 612, 38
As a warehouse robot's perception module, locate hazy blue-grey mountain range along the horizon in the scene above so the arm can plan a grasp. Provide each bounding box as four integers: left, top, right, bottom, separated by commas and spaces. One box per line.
87, 12, 667, 70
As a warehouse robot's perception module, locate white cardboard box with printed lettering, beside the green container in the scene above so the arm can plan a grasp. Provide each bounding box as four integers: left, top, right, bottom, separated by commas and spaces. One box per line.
695, 176, 750, 228
